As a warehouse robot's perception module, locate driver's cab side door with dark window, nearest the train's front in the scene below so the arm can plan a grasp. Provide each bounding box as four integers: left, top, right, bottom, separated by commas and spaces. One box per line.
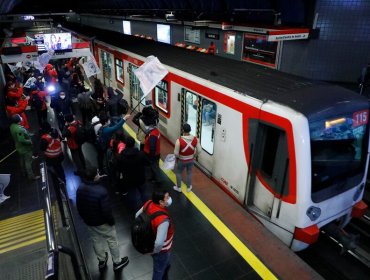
245, 120, 289, 219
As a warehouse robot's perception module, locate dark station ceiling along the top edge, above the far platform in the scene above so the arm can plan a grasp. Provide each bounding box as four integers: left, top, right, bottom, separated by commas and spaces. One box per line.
0, 0, 316, 26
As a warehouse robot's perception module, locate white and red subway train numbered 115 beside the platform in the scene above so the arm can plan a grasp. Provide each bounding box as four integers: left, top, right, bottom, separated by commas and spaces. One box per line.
72, 27, 369, 251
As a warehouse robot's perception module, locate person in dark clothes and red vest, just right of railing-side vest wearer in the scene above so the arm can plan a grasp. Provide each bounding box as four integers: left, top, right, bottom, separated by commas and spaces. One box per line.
62, 115, 86, 176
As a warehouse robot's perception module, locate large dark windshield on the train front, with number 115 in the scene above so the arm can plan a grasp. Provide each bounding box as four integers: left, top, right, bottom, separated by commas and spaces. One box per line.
310, 110, 369, 202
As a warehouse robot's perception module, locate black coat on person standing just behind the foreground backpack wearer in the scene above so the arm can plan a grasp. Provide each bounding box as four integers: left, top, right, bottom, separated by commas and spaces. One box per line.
118, 147, 150, 188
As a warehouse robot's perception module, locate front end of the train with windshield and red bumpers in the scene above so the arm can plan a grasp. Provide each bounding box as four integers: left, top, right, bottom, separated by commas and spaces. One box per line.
290, 86, 369, 251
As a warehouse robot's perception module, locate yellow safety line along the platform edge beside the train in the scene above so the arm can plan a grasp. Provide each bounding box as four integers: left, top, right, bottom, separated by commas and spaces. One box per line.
124, 124, 278, 280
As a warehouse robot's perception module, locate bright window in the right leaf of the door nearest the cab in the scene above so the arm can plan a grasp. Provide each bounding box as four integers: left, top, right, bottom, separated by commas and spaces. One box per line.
200, 99, 217, 155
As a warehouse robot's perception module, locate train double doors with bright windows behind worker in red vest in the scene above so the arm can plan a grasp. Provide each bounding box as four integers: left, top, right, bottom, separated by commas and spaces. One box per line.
181, 89, 217, 175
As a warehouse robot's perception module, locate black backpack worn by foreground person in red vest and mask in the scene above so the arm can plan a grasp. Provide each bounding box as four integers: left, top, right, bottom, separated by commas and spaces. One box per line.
131, 201, 168, 254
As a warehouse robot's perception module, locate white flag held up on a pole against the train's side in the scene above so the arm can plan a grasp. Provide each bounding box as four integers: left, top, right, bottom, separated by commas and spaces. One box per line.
134, 55, 168, 98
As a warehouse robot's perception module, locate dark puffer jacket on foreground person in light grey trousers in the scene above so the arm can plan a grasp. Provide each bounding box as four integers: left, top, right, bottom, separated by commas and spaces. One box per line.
76, 182, 114, 226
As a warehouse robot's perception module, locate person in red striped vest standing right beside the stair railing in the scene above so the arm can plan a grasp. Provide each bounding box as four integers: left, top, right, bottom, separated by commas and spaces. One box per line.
40, 122, 66, 182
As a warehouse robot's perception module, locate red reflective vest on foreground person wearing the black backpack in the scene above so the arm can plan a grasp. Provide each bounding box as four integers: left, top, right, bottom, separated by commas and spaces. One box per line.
143, 201, 175, 252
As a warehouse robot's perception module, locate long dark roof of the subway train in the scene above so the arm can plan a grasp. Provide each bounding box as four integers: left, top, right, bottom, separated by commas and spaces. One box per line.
68, 24, 367, 119
